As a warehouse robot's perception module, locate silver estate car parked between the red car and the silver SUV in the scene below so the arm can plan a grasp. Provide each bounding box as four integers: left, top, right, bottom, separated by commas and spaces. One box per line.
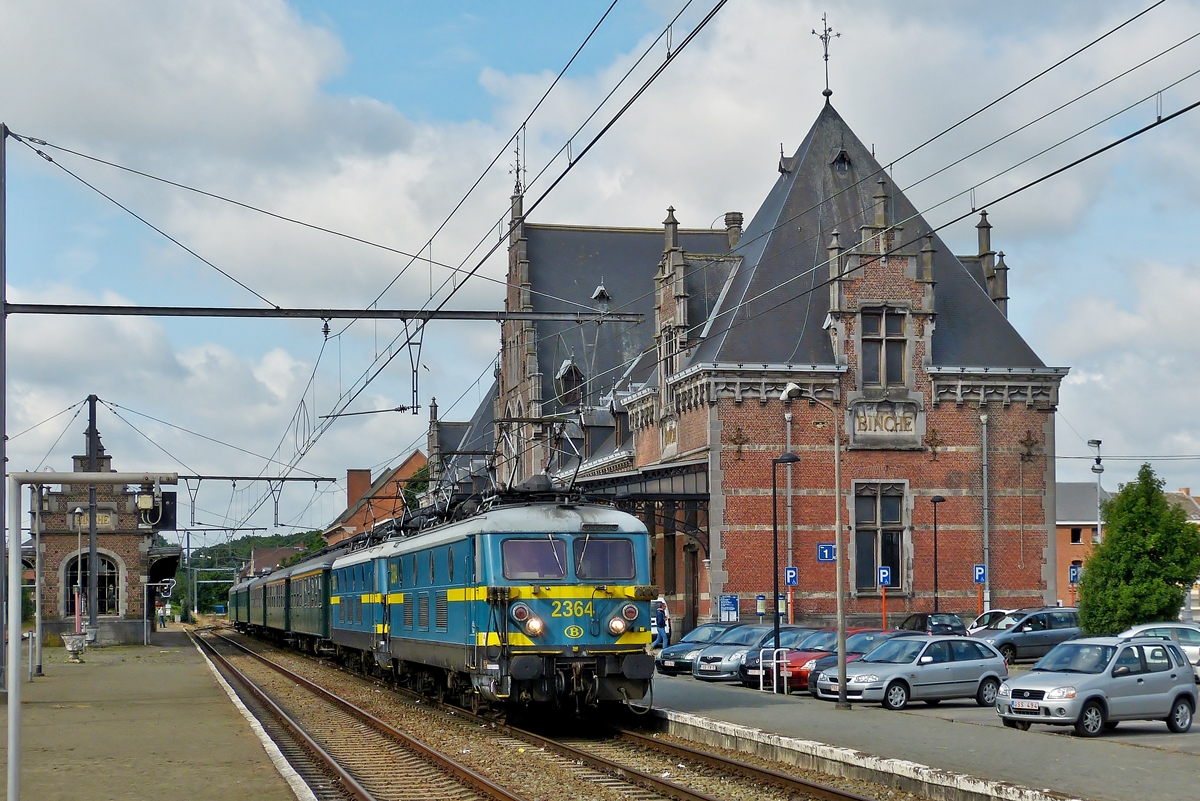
817, 636, 1008, 709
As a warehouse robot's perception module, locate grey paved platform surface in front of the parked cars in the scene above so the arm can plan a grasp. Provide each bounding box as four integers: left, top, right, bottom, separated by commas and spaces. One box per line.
654, 675, 1200, 801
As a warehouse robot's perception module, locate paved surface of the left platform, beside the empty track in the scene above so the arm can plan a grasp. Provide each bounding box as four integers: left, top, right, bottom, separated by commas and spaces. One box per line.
0, 627, 295, 801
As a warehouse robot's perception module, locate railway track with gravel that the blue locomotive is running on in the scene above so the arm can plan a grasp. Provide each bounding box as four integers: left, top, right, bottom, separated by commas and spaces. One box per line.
204, 623, 907, 801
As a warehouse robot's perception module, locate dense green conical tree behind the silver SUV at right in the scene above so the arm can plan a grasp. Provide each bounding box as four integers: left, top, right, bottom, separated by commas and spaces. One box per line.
1079, 464, 1200, 634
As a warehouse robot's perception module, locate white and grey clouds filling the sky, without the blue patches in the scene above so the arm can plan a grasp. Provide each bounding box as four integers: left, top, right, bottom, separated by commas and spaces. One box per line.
11, 0, 1200, 532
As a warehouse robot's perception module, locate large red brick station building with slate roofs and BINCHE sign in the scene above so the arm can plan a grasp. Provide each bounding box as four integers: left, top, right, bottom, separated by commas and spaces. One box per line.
428, 100, 1067, 636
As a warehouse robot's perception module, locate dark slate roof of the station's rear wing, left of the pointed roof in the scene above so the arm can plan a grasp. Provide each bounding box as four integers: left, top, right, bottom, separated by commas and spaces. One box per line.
524, 223, 728, 414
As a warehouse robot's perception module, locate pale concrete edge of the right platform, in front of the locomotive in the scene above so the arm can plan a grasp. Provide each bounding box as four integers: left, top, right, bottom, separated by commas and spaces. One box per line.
654, 709, 1082, 801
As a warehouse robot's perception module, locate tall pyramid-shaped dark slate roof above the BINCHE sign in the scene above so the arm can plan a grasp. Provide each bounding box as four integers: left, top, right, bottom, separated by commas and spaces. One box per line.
691, 103, 1044, 367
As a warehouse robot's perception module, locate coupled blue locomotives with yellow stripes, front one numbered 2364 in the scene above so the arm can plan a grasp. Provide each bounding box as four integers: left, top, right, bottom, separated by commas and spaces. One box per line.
330, 502, 655, 707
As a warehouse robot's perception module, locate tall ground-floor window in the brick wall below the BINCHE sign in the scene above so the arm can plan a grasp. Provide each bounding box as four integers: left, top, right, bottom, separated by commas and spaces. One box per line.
854, 483, 904, 592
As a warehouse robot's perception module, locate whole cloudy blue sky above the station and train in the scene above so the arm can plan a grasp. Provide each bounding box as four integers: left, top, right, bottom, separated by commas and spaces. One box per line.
0, 0, 1200, 544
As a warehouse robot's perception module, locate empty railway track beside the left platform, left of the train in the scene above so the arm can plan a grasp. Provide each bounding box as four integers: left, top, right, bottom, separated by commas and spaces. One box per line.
194, 637, 524, 801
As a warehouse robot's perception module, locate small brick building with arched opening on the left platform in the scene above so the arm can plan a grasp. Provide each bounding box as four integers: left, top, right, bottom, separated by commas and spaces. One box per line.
32, 436, 182, 644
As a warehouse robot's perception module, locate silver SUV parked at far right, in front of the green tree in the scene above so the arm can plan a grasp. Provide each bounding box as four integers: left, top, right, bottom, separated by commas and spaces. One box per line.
996, 637, 1196, 737
